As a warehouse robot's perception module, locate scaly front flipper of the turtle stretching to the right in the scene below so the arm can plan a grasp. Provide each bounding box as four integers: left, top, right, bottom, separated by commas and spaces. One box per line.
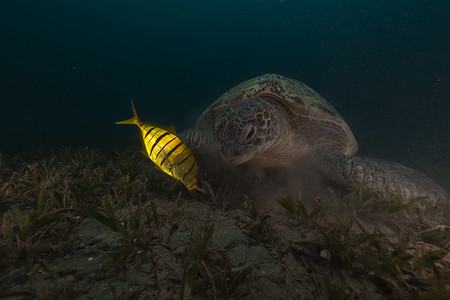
317, 154, 449, 205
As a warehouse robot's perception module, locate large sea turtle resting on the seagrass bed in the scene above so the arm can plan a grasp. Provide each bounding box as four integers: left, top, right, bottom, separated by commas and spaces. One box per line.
180, 74, 448, 204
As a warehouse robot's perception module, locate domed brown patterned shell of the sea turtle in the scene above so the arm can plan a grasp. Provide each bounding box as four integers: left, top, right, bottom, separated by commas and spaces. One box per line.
195, 74, 358, 155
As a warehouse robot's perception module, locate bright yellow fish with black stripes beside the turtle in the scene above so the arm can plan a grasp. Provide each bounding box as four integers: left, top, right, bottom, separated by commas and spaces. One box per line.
116, 100, 198, 190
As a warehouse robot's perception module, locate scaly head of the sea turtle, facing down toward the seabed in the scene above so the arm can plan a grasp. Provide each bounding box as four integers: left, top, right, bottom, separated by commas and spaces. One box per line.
214, 98, 280, 164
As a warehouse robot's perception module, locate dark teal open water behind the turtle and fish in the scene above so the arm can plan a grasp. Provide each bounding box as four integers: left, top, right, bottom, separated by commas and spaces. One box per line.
0, 0, 450, 187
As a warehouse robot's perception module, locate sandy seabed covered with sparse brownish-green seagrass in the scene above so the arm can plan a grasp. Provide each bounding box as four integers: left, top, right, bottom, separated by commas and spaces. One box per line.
0, 147, 450, 299
